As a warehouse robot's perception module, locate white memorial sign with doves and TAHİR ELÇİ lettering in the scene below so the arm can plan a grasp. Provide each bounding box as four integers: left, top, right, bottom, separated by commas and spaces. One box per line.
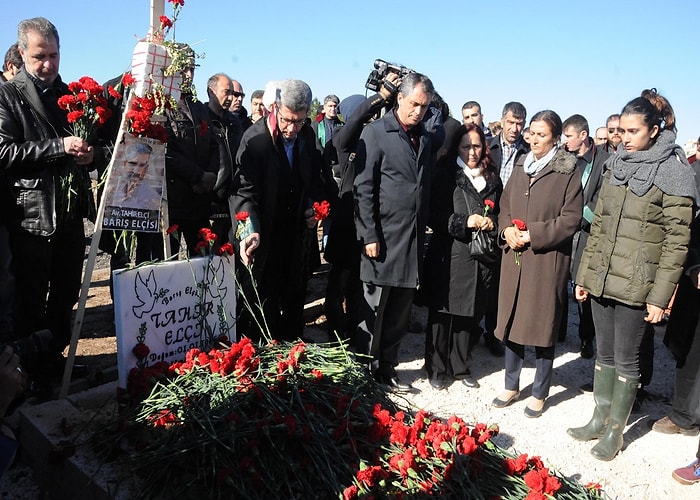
114, 256, 236, 388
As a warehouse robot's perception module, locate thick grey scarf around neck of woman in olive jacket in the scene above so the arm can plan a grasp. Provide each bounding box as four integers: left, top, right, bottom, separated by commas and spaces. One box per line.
606, 130, 698, 206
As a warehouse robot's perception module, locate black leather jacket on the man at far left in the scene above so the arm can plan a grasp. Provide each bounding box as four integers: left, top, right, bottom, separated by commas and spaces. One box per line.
0, 68, 89, 236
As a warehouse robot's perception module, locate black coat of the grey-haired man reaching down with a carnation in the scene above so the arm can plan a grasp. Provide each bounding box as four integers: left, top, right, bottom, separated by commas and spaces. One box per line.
229, 115, 324, 286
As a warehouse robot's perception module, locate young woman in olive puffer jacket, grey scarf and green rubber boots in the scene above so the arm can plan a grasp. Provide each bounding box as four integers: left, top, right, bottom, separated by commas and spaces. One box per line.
567, 89, 697, 460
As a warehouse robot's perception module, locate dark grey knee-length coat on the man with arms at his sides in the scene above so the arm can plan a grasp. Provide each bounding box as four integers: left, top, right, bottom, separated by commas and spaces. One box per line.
354, 112, 434, 288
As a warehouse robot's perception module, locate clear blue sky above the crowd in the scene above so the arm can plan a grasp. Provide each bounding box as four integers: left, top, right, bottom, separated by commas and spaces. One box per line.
5, 0, 700, 144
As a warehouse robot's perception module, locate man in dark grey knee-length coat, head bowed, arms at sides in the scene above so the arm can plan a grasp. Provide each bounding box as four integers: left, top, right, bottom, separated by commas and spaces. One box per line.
354, 73, 435, 391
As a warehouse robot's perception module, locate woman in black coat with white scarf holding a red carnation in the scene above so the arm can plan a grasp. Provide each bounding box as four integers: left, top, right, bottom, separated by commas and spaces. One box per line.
422, 124, 503, 390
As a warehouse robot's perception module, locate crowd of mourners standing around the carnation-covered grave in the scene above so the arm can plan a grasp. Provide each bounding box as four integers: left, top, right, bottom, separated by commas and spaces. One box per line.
0, 18, 700, 484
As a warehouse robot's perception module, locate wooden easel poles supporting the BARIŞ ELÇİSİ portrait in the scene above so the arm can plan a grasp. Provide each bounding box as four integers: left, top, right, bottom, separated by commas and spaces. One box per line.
58, 0, 170, 399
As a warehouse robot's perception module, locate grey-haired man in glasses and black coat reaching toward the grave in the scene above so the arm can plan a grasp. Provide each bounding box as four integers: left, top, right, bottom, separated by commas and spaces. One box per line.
229, 80, 324, 340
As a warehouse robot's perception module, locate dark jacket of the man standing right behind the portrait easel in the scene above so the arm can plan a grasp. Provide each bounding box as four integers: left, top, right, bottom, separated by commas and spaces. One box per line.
165, 94, 219, 220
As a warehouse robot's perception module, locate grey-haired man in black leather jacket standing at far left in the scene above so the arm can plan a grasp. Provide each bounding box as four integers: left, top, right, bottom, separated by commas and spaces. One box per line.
0, 17, 95, 388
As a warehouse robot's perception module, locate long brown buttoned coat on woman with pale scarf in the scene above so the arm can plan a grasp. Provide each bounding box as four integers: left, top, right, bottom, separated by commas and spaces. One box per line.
495, 150, 583, 347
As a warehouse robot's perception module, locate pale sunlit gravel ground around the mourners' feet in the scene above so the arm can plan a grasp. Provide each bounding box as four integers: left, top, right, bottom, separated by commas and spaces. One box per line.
0, 250, 700, 500
